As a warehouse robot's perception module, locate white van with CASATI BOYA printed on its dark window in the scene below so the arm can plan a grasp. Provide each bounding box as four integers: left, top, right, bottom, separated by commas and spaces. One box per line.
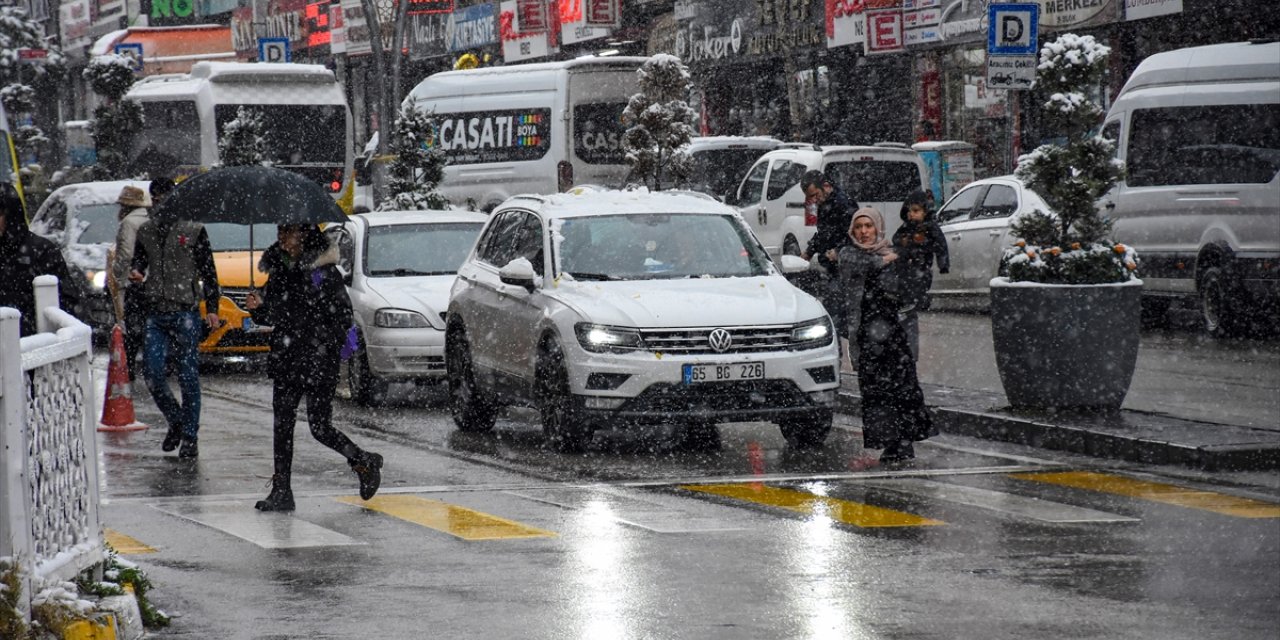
404, 56, 646, 211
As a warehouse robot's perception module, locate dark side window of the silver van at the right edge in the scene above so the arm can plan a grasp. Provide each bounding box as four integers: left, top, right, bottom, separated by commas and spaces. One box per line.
1128, 105, 1280, 187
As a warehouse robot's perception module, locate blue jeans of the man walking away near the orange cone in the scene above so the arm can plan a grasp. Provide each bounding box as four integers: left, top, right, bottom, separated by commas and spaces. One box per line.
143, 311, 202, 442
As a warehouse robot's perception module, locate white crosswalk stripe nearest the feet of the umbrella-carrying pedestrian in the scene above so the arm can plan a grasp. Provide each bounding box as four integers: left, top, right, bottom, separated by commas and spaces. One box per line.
156, 502, 365, 549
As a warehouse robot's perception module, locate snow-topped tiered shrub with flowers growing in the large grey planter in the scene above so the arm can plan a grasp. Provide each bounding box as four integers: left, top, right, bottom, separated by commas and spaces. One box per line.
1004, 33, 1138, 284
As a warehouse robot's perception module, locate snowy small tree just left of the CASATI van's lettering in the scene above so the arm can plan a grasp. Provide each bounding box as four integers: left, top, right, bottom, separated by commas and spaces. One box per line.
378, 105, 449, 211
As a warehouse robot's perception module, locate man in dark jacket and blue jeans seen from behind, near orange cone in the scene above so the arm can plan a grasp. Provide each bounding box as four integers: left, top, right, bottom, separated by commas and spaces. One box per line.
129, 197, 223, 458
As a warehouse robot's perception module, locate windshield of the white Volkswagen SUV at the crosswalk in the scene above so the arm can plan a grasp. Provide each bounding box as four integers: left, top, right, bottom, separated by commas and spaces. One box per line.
557, 214, 769, 280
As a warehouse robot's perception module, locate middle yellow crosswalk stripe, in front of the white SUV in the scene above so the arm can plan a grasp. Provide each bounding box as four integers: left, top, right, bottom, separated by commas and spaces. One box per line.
681, 484, 946, 527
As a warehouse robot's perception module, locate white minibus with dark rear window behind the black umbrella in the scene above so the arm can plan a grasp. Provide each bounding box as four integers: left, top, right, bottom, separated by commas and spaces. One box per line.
124, 61, 355, 212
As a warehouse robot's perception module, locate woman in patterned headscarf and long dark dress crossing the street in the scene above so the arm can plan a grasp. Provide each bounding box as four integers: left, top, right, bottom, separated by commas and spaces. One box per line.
838, 207, 937, 463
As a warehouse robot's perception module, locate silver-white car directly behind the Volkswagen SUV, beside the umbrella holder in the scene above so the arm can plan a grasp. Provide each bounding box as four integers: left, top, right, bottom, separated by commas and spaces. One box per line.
325, 211, 488, 404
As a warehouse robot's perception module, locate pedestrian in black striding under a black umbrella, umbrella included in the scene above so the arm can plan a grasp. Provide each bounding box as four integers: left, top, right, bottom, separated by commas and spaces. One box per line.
165, 165, 383, 511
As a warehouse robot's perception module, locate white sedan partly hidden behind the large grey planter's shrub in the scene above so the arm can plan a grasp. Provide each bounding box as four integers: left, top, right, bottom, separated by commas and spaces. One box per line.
931, 175, 1050, 296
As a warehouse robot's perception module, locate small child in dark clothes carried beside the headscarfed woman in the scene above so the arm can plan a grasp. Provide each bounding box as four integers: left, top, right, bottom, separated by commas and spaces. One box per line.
893, 189, 951, 360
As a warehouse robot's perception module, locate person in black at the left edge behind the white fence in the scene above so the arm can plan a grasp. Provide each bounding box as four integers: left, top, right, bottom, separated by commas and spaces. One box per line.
0, 183, 81, 335
